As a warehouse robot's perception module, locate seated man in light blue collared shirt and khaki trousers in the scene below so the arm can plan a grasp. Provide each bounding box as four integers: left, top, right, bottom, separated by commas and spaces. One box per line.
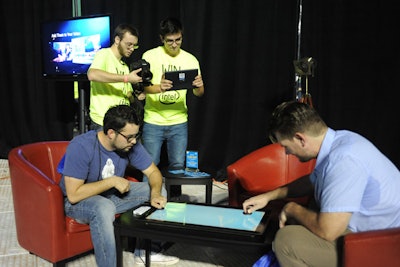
243, 101, 400, 267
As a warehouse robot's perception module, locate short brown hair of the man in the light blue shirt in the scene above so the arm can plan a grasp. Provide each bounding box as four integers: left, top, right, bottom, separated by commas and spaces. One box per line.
269, 101, 327, 143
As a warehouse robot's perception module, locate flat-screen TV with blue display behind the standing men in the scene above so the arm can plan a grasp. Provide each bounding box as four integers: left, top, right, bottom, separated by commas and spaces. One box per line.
41, 15, 111, 80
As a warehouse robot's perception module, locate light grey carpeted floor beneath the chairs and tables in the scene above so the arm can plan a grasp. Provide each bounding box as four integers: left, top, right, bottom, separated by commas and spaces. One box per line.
0, 159, 260, 267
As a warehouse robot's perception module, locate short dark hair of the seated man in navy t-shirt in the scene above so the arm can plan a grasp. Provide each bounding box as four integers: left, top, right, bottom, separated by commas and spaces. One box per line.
103, 105, 141, 134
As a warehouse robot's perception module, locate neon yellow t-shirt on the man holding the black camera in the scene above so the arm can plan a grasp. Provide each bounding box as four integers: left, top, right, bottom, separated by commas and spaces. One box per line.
89, 48, 132, 125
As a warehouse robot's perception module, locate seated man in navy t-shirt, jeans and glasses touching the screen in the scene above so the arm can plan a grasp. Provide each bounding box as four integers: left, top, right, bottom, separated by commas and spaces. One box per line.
60, 105, 179, 267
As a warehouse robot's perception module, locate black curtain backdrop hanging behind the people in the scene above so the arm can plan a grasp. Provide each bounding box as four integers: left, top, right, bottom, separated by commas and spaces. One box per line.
0, 0, 400, 177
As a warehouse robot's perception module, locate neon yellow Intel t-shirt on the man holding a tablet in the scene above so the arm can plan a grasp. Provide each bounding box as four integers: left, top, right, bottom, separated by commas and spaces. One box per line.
143, 46, 200, 126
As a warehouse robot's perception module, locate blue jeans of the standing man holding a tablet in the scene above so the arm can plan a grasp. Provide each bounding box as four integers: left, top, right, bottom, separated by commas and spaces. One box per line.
142, 122, 188, 182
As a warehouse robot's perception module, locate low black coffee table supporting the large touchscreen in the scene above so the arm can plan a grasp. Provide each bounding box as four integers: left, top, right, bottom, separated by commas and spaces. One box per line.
114, 203, 276, 266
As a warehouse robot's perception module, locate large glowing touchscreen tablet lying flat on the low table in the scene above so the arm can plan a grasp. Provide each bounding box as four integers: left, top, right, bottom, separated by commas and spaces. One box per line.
133, 202, 270, 243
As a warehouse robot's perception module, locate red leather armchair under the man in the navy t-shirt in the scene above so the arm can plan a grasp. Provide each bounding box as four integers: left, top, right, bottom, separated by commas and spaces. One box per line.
8, 141, 93, 263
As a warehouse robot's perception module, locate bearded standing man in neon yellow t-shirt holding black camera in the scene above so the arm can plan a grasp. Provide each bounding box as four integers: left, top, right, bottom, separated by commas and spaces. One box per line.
87, 24, 142, 130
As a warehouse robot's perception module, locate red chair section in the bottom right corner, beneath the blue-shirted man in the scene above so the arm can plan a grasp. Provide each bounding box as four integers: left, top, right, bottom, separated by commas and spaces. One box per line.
343, 228, 400, 267
